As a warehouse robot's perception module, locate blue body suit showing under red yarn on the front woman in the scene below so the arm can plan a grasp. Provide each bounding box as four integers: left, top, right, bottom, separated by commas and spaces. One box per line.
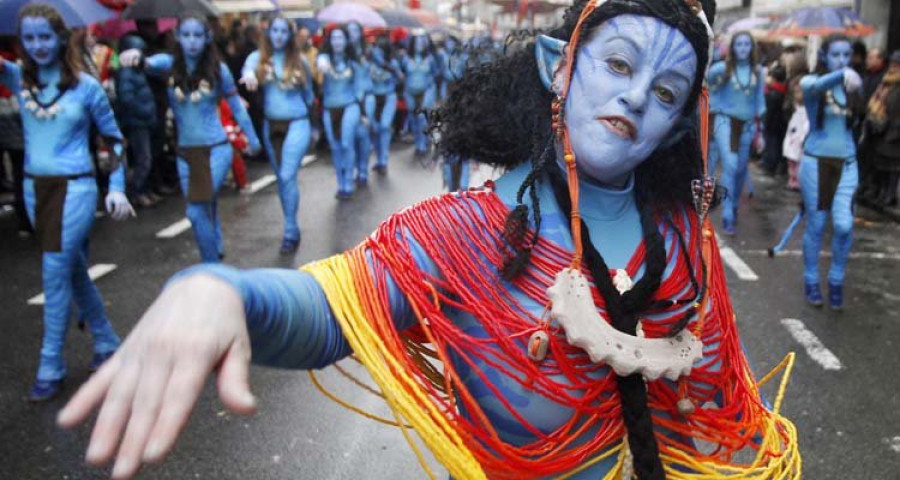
179, 164, 718, 480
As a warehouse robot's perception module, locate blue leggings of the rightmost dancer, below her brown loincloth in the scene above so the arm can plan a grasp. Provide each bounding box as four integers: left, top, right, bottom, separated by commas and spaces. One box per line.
799, 155, 859, 285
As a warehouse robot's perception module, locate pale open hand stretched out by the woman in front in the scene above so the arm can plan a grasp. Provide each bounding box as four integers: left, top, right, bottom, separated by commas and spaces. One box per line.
57, 274, 256, 479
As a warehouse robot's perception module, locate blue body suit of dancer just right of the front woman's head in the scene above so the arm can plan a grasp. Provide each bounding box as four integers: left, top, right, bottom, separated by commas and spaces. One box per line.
707, 62, 766, 228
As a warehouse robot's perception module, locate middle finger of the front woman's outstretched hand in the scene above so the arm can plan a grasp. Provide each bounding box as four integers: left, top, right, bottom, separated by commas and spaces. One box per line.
112, 355, 172, 478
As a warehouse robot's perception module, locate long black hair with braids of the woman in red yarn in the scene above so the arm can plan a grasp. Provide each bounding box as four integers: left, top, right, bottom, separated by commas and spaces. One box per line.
433, 0, 715, 480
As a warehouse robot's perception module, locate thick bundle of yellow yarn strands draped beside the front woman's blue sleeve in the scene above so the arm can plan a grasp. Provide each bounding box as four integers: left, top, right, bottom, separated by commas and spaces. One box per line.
303, 254, 487, 479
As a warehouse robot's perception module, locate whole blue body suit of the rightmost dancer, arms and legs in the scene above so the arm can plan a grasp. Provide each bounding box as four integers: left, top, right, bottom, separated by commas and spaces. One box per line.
799, 70, 859, 285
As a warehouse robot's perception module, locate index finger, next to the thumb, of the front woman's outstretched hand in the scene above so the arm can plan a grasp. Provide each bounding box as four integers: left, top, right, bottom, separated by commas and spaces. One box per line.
144, 362, 212, 463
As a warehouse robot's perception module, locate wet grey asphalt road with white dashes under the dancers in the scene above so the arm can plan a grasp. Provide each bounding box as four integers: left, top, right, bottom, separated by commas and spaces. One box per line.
0, 145, 900, 480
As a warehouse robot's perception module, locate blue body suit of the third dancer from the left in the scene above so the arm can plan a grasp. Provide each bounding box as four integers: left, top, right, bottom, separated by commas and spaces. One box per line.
243, 51, 314, 244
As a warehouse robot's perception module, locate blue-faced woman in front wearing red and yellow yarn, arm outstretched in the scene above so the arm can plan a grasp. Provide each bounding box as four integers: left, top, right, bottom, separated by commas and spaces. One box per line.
59, 0, 801, 480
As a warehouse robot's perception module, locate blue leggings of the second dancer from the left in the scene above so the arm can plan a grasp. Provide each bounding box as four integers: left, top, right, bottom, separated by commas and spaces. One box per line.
178, 144, 234, 263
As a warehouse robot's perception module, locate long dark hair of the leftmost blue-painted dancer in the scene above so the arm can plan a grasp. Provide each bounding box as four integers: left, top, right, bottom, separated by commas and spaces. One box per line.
17, 3, 86, 92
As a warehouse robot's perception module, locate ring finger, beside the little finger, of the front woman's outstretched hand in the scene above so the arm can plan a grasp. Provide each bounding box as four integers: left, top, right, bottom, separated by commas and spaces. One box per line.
85, 361, 141, 466
